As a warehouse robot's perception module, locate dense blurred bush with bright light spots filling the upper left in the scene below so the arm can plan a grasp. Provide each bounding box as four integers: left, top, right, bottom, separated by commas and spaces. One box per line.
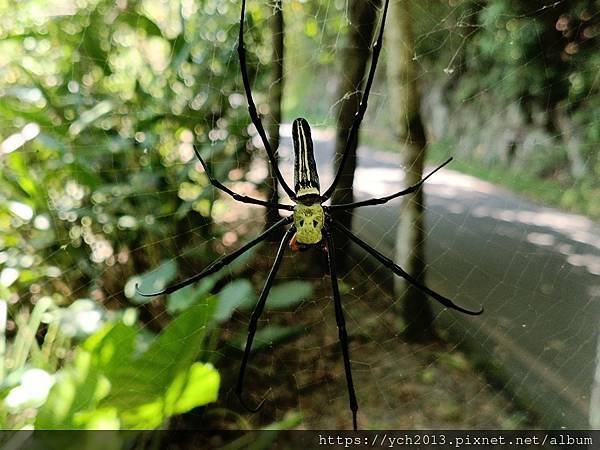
0, 0, 258, 310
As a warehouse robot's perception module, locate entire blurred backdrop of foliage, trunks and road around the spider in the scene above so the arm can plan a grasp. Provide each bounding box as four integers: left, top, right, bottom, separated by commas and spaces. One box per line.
0, 0, 600, 438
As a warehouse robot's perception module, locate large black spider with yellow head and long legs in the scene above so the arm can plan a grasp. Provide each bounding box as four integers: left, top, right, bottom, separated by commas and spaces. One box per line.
136, 0, 483, 430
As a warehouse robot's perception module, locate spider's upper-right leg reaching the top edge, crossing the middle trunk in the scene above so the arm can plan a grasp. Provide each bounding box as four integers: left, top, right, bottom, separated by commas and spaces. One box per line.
321, 0, 390, 202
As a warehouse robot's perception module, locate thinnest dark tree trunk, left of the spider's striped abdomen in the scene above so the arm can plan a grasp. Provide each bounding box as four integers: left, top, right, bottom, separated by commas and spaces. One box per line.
265, 0, 284, 228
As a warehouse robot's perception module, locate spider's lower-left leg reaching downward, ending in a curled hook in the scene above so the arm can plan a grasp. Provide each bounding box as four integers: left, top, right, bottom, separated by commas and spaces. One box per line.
235, 226, 296, 412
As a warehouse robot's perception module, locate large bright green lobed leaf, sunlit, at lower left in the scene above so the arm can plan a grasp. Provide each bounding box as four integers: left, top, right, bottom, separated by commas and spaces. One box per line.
36, 306, 220, 429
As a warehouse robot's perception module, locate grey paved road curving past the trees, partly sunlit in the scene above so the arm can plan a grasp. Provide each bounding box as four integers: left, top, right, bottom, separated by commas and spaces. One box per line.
280, 127, 600, 428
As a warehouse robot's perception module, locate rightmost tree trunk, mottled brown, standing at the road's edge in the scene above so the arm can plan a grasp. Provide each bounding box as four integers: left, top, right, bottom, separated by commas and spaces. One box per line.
386, 0, 435, 340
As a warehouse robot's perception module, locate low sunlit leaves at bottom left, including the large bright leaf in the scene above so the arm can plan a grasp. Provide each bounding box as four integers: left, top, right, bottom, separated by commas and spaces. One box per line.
0, 262, 312, 429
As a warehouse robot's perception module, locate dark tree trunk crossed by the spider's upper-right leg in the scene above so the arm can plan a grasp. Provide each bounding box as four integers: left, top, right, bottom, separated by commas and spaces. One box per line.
331, 0, 381, 253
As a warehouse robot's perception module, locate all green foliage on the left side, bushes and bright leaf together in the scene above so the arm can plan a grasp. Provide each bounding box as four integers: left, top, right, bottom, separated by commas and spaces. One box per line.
0, 0, 310, 429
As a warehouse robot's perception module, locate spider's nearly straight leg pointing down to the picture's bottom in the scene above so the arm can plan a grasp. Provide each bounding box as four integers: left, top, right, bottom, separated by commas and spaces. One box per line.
323, 229, 358, 431
